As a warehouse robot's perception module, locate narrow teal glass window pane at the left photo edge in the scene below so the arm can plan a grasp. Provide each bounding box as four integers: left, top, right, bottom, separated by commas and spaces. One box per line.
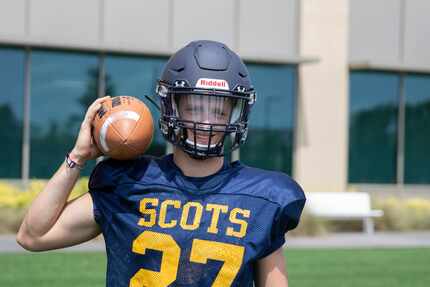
0, 48, 25, 178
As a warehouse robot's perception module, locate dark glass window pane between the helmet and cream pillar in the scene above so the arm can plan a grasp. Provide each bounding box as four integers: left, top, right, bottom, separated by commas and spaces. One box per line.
240, 64, 297, 174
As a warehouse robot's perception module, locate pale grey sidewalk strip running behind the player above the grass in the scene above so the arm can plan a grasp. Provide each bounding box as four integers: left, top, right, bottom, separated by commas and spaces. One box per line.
0, 231, 430, 253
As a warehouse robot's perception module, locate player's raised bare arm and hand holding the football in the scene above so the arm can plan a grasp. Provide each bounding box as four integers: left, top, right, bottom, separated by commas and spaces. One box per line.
17, 97, 111, 251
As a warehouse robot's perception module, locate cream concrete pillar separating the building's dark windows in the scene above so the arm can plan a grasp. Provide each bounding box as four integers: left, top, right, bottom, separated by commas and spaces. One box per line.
293, 0, 349, 194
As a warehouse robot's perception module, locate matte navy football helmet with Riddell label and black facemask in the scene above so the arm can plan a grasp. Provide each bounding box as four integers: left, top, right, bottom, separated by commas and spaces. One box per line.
156, 41, 256, 159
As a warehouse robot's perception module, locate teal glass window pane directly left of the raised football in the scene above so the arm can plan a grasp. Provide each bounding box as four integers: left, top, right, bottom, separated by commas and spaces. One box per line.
30, 50, 98, 178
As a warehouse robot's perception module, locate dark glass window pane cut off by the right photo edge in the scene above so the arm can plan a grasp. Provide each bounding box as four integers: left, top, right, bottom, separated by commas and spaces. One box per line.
404, 75, 430, 183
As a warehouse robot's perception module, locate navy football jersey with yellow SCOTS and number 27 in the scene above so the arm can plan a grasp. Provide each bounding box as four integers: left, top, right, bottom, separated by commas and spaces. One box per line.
89, 155, 305, 287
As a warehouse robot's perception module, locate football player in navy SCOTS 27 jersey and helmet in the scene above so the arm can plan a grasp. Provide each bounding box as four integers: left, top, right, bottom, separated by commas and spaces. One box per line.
17, 41, 305, 287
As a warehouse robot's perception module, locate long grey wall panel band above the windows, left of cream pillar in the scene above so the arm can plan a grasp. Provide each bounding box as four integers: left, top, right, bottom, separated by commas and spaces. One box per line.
0, 0, 299, 62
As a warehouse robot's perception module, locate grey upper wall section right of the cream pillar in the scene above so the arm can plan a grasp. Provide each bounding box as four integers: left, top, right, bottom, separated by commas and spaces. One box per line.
349, 0, 430, 69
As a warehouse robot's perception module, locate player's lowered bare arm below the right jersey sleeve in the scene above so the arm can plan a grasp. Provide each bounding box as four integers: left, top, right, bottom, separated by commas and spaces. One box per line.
256, 247, 288, 287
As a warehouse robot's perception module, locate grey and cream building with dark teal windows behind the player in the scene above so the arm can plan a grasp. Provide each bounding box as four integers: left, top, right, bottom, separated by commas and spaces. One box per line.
0, 0, 430, 194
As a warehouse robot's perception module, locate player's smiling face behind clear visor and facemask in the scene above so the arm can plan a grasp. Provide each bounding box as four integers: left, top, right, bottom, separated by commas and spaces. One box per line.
178, 95, 232, 146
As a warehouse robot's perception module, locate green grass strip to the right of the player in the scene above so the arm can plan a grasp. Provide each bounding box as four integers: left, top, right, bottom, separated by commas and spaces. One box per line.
286, 248, 430, 287
